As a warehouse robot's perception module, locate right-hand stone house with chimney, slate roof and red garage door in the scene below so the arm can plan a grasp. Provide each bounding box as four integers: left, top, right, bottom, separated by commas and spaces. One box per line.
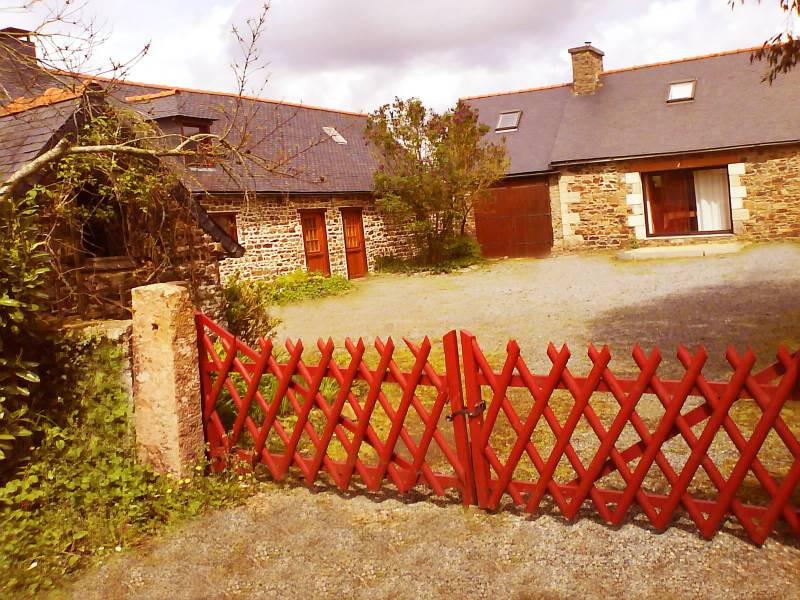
464, 44, 800, 256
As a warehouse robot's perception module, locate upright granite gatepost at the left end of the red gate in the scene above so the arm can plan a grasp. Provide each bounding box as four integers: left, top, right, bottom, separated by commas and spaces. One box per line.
131, 283, 204, 477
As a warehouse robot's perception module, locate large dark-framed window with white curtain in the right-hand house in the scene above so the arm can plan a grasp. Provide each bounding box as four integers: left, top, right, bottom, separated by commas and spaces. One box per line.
642, 167, 731, 236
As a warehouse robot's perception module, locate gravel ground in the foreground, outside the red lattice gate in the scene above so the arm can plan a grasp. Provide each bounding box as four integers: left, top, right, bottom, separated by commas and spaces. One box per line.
73, 488, 800, 600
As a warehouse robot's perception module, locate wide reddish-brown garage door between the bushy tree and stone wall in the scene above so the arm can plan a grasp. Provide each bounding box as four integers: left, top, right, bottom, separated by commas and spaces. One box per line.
475, 179, 553, 257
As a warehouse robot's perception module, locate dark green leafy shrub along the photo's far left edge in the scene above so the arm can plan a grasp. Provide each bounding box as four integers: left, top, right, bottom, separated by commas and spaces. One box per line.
0, 183, 48, 464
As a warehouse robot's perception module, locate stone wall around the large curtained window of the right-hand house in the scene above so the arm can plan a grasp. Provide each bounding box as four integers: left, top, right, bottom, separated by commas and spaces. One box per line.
550, 146, 800, 250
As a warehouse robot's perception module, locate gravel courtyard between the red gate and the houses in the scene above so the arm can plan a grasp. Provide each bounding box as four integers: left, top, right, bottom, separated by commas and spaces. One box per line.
277, 244, 800, 374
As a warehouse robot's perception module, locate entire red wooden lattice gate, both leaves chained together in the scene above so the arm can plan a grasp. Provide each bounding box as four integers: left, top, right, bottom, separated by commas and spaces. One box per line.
197, 313, 800, 544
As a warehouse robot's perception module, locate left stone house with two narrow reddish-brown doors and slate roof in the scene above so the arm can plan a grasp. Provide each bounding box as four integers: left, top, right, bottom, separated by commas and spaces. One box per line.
108, 79, 410, 279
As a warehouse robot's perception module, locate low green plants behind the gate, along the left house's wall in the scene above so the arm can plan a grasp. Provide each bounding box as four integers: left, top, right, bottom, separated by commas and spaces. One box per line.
224, 270, 351, 344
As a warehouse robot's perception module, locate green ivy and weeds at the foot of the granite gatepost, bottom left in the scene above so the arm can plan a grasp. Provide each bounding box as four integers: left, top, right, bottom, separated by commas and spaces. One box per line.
0, 338, 253, 597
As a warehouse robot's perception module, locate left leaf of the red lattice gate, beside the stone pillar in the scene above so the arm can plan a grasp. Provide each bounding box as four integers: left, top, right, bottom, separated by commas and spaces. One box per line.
197, 313, 474, 504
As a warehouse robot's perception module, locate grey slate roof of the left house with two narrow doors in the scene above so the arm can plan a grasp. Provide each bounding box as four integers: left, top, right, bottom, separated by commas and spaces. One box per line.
112, 82, 377, 193
